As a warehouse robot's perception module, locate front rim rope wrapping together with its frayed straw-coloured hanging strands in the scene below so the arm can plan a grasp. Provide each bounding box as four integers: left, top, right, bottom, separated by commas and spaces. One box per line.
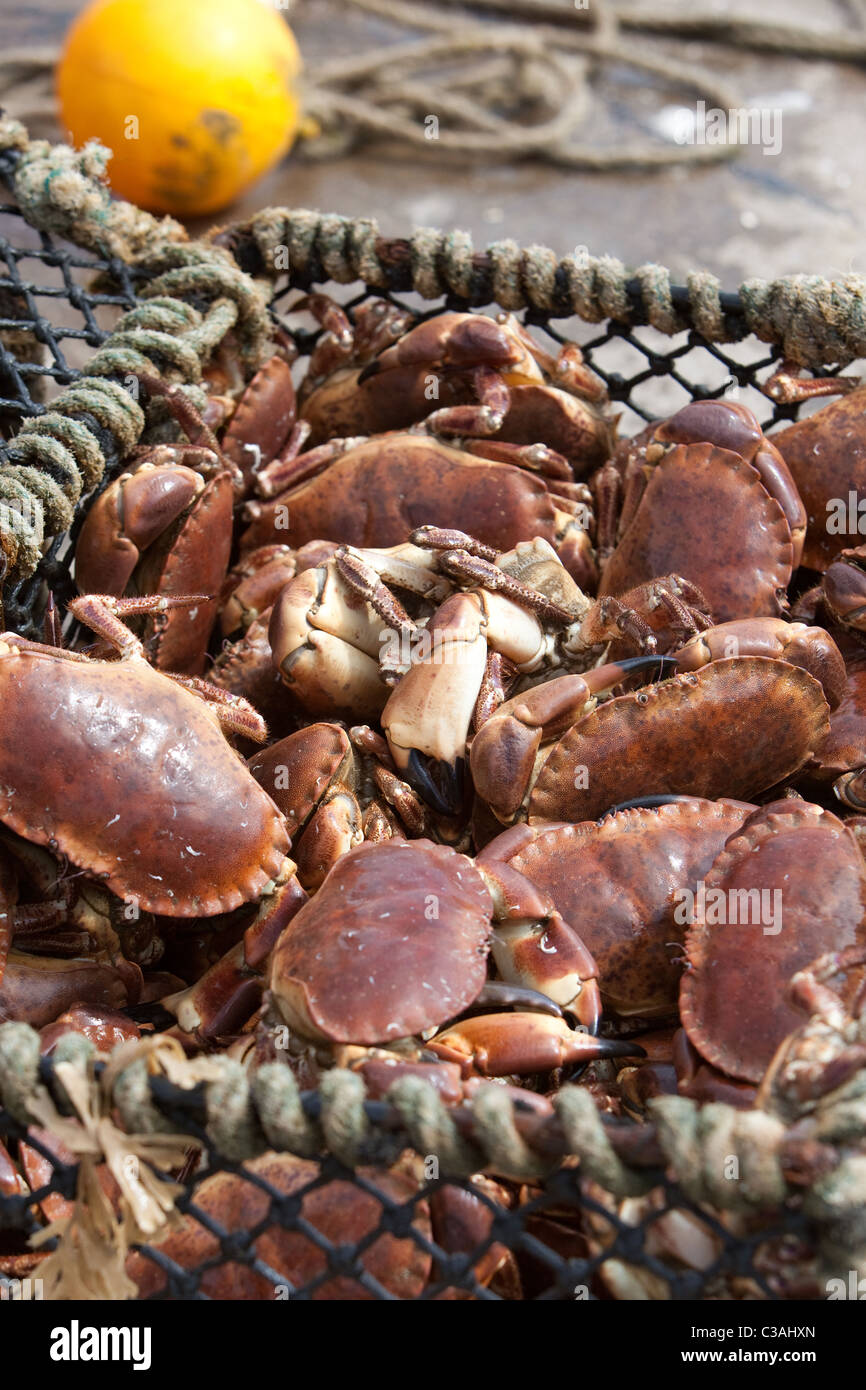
0, 1023, 866, 1297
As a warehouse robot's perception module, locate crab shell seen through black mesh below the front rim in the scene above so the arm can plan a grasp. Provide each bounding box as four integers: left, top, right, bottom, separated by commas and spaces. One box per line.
126, 1152, 432, 1301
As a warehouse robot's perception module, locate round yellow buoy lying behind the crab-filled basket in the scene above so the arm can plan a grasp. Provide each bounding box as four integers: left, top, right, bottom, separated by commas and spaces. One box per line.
57, 0, 300, 217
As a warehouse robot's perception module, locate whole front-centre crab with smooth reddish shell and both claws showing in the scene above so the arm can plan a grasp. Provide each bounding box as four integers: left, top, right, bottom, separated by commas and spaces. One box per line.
261, 840, 647, 1076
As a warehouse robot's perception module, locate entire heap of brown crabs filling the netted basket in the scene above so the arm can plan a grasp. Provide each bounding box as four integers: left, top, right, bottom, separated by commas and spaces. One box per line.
0, 295, 866, 1297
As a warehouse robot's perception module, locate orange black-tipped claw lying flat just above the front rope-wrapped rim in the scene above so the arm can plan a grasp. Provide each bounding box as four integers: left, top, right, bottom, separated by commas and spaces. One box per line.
427, 1013, 645, 1076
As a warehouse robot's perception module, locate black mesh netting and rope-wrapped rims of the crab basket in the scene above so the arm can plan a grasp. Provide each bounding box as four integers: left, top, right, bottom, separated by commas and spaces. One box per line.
0, 128, 866, 1300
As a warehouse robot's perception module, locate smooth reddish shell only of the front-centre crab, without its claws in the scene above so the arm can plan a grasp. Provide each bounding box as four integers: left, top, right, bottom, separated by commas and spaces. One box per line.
270, 840, 492, 1045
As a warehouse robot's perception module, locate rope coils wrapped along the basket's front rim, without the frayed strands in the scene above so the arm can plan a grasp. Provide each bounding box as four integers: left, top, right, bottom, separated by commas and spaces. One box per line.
0, 1023, 866, 1225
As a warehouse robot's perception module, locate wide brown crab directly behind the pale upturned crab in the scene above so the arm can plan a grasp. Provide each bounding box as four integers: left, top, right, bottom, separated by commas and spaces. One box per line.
240, 432, 596, 585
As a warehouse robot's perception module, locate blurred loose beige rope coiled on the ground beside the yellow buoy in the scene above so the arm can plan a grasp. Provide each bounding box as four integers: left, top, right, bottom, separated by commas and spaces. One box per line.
0, 0, 866, 171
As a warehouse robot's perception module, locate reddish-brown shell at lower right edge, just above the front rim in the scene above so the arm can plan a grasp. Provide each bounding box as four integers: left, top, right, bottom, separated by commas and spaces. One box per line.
680, 801, 866, 1081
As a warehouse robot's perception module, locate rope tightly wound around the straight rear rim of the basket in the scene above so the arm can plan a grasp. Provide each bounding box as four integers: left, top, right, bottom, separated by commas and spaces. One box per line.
225, 207, 866, 367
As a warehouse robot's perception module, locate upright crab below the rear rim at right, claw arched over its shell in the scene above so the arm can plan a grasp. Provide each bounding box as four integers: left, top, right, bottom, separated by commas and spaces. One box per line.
595, 400, 806, 621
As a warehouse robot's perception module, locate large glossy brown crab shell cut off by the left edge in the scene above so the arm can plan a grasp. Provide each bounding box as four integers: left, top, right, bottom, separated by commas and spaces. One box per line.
0, 634, 289, 917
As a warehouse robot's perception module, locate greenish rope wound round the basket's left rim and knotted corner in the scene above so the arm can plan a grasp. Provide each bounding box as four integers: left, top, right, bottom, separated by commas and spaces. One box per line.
0, 118, 270, 582
